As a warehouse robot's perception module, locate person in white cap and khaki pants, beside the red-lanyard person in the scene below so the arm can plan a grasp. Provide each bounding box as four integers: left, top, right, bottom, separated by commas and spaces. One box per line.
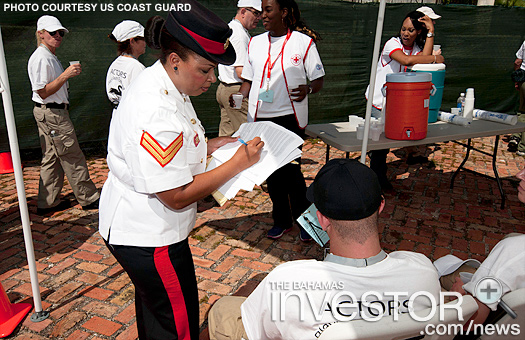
217, 0, 262, 136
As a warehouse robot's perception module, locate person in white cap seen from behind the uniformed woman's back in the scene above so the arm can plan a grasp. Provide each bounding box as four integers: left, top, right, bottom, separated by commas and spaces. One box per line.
106, 20, 146, 108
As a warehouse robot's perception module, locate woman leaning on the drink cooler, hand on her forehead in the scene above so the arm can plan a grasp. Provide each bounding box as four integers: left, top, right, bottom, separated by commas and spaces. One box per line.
365, 11, 445, 190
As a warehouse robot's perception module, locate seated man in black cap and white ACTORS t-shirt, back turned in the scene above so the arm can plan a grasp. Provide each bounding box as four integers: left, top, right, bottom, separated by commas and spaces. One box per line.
208, 159, 440, 340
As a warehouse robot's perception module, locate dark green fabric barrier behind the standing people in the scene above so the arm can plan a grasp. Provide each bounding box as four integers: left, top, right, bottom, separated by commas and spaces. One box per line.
0, 0, 525, 151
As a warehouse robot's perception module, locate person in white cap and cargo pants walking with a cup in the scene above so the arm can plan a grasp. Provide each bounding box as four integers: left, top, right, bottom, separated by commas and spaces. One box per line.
27, 15, 100, 215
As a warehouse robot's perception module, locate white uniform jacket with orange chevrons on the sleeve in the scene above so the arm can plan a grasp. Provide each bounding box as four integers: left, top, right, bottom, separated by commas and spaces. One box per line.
99, 61, 207, 247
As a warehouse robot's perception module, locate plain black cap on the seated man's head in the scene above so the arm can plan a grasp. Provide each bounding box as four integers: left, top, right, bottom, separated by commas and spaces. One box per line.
306, 159, 383, 221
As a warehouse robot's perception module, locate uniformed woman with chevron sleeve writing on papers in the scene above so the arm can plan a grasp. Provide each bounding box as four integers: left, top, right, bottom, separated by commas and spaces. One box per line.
99, 0, 263, 340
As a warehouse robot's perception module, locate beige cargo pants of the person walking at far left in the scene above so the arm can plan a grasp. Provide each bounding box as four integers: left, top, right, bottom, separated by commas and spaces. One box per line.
33, 106, 100, 208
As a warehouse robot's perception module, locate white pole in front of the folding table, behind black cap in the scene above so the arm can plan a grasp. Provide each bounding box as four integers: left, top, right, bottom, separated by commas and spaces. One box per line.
360, 0, 386, 164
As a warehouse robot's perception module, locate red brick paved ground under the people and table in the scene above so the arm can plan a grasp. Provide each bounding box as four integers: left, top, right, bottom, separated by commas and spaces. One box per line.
0, 138, 525, 340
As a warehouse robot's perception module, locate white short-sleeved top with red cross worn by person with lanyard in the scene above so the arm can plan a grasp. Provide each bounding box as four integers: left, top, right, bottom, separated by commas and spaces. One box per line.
242, 31, 325, 128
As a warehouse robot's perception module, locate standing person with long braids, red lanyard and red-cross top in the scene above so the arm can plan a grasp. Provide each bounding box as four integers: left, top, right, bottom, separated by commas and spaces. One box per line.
230, 0, 325, 241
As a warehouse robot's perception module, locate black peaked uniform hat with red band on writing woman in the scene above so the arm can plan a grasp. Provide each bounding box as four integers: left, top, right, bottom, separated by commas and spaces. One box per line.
164, 0, 236, 65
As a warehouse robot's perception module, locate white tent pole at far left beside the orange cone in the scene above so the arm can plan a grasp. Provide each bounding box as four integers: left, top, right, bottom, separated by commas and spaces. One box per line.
0, 28, 49, 322
